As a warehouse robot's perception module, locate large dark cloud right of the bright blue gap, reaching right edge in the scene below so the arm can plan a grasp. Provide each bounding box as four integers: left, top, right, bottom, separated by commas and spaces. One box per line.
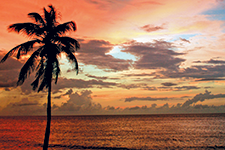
118, 41, 225, 79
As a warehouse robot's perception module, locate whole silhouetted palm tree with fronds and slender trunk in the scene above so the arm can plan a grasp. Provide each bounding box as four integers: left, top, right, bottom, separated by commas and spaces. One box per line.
0, 5, 80, 150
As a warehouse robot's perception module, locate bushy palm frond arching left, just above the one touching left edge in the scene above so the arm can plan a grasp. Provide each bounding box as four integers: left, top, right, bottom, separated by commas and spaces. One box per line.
8, 22, 41, 36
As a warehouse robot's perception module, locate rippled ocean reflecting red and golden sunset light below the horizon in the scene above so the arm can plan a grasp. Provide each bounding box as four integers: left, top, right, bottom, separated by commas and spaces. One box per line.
0, 114, 225, 150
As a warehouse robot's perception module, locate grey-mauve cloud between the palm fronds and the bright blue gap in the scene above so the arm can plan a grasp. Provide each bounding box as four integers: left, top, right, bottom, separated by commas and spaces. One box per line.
77, 40, 132, 71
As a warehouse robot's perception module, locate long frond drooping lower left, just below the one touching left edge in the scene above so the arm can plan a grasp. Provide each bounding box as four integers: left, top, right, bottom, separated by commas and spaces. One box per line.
17, 47, 43, 85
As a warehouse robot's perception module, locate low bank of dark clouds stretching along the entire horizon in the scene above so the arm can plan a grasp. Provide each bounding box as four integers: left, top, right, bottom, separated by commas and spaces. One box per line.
0, 90, 225, 115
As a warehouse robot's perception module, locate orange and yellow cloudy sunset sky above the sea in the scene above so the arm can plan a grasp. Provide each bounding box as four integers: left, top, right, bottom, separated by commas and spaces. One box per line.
0, 0, 225, 115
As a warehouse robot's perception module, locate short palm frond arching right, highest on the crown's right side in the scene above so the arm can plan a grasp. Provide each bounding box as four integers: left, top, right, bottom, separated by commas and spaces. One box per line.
55, 21, 76, 35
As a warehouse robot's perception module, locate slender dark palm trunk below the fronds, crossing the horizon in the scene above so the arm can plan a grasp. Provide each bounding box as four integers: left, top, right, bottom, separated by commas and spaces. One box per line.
43, 83, 51, 150
